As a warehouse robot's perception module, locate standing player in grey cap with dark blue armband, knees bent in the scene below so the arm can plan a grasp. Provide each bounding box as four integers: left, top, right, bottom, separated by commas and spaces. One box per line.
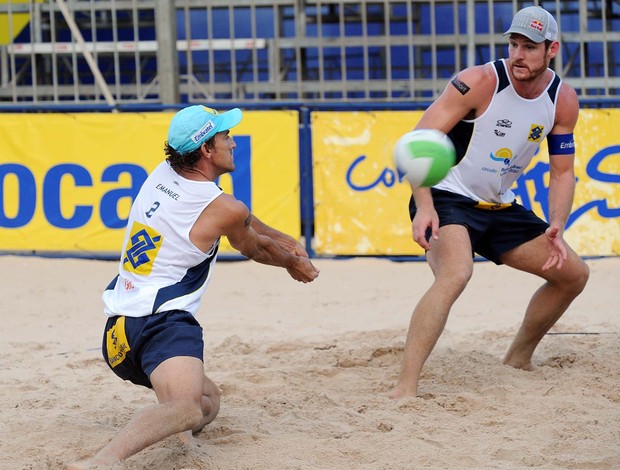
390, 7, 589, 398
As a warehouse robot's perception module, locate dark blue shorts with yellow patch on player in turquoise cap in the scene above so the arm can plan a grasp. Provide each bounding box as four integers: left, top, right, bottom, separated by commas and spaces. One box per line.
102, 310, 204, 388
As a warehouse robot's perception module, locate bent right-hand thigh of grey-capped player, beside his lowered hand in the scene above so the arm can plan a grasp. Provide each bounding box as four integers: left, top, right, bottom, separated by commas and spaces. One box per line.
501, 234, 589, 282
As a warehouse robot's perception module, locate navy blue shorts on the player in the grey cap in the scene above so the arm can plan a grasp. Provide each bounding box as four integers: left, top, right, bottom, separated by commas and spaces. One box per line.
409, 188, 549, 264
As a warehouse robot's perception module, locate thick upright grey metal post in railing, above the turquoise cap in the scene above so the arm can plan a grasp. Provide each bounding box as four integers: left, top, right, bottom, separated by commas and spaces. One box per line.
155, 0, 179, 104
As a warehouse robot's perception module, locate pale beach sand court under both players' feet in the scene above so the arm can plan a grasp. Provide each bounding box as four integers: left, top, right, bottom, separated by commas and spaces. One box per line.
0, 256, 620, 470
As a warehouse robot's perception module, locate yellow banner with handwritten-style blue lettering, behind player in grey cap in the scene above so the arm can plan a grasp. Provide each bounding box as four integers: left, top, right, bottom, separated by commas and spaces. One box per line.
312, 109, 620, 256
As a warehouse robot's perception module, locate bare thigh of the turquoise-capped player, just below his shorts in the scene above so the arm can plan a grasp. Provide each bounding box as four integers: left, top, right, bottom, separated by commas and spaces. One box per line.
150, 356, 205, 403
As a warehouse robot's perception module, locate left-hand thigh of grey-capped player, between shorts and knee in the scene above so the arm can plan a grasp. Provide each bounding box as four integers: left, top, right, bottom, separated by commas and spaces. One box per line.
426, 224, 474, 282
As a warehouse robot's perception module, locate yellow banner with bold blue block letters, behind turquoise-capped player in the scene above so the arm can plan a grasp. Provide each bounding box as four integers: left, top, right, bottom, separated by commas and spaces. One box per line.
0, 111, 301, 256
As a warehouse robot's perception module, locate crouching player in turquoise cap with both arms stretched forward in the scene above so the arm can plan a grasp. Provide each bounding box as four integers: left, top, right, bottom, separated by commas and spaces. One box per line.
69, 106, 319, 469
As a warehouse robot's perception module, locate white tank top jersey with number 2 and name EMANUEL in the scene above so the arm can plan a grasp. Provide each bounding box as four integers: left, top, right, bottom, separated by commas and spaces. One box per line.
103, 161, 222, 317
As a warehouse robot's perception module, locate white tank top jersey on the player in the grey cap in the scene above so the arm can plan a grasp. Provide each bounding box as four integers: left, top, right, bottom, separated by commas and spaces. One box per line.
434, 59, 562, 205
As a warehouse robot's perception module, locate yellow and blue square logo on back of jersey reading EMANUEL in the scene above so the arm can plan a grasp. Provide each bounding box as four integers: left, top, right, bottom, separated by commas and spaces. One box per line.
123, 222, 164, 276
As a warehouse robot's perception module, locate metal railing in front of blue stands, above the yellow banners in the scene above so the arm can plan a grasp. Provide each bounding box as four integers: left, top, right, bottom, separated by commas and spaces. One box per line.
0, 0, 620, 107
